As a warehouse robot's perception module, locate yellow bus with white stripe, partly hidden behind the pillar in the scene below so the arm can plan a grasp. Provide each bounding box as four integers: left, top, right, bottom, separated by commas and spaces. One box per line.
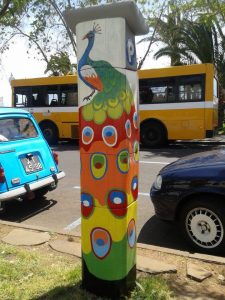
11, 64, 218, 147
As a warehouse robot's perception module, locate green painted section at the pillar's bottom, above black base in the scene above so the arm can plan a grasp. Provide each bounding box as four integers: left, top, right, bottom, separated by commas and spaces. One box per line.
83, 235, 136, 280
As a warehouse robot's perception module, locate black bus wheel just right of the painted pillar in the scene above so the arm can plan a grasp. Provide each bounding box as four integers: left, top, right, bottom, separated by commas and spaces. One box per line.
140, 122, 167, 147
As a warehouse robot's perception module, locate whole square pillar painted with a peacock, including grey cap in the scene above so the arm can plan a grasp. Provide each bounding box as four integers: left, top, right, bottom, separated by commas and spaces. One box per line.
63, 1, 148, 297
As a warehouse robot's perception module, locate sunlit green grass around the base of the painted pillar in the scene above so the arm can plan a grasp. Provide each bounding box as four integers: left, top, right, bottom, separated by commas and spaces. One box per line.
0, 244, 172, 300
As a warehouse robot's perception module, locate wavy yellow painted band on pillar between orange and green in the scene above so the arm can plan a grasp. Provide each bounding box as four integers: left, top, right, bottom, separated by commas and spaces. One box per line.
81, 201, 137, 254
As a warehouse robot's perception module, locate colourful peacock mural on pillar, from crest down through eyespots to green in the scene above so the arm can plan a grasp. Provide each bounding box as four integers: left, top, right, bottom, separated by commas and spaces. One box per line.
78, 24, 139, 296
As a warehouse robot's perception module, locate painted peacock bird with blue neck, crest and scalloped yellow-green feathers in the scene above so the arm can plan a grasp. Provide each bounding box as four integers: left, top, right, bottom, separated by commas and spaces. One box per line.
78, 24, 133, 124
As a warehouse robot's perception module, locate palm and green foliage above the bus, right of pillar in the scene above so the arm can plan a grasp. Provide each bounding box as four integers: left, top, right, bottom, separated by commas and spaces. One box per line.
146, 0, 225, 88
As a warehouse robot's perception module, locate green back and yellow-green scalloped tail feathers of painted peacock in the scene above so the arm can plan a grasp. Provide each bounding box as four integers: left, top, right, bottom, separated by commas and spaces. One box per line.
82, 59, 134, 124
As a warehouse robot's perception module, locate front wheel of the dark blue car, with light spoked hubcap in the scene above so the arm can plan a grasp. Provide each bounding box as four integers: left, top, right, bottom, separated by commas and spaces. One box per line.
179, 196, 225, 254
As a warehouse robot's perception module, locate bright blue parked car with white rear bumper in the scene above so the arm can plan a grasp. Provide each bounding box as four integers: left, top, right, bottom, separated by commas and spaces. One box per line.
0, 108, 65, 211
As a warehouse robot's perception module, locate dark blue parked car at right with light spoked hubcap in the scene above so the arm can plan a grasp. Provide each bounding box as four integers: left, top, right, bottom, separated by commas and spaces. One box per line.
150, 150, 225, 254
